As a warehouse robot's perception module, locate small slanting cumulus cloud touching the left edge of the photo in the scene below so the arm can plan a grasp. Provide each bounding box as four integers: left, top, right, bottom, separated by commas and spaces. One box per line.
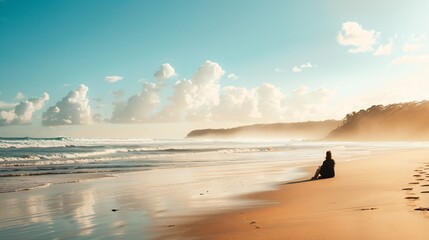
0, 93, 49, 126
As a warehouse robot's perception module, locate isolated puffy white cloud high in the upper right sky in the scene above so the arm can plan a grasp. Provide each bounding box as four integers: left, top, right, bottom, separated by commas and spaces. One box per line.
337, 22, 380, 53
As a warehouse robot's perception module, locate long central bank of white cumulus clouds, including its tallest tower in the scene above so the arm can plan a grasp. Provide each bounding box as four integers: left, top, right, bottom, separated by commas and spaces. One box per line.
111, 61, 334, 123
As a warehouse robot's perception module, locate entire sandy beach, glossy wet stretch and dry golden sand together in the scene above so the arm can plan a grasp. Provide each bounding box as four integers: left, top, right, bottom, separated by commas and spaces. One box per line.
0, 143, 429, 240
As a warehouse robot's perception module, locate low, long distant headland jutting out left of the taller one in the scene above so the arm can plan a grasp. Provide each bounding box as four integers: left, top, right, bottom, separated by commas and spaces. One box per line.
187, 120, 341, 139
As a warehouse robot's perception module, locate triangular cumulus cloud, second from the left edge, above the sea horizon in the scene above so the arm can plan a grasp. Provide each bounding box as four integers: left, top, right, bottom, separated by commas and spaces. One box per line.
42, 84, 92, 126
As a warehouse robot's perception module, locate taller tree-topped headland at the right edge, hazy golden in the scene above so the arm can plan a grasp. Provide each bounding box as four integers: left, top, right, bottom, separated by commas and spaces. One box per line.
327, 101, 429, 141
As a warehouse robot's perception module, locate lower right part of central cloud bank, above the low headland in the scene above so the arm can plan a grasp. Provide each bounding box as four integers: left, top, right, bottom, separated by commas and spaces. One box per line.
212, 83, 341, 123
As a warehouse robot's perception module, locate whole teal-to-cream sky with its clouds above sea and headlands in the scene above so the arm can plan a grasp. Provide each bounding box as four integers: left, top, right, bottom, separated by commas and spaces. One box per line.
0, 0, 429, 138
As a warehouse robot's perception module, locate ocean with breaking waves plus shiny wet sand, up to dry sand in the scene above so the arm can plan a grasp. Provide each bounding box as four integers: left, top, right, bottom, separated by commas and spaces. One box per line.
0, 137, 429, 239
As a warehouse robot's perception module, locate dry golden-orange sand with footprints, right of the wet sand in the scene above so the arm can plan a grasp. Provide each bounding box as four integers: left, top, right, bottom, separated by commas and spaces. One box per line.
163, 150, 429, 240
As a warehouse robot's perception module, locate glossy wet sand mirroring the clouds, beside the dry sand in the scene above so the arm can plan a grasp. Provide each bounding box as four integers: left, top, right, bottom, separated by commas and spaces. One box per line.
0, 155, 308, 239
